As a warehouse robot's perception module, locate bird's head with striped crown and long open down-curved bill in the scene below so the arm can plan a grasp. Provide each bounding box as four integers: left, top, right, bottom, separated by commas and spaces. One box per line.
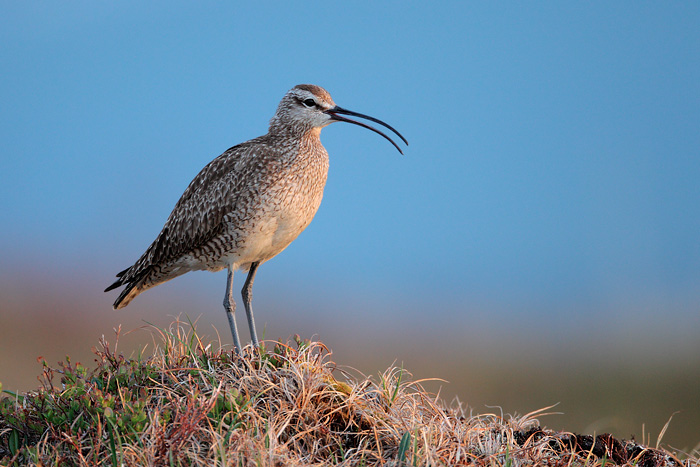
270, 84, 408, 154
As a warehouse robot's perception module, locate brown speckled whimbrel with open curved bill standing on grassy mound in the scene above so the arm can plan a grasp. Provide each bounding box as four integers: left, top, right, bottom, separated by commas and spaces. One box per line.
105, 84, 408, 352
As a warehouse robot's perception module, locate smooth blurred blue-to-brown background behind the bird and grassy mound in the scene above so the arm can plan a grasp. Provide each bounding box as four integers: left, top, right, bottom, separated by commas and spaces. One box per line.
0, 1, 700, 450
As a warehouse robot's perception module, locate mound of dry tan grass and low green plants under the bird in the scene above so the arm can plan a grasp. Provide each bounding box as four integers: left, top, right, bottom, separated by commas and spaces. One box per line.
0, 321, 700, 467
